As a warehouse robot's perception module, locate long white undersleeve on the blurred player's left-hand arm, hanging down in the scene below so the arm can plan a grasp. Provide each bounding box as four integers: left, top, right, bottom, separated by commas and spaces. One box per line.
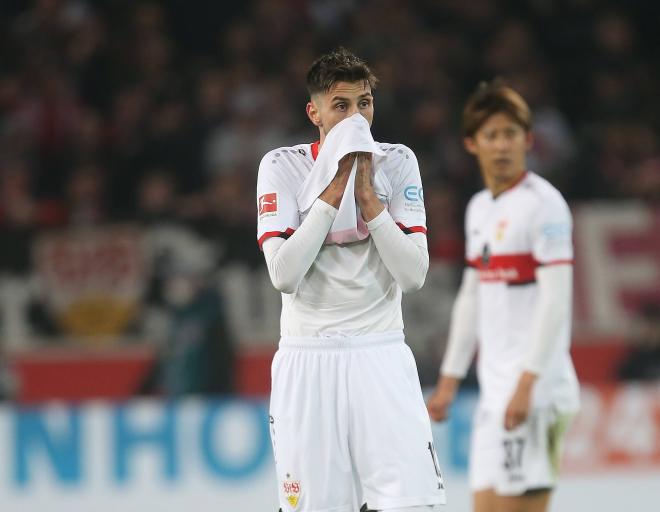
441, 267, 479, 379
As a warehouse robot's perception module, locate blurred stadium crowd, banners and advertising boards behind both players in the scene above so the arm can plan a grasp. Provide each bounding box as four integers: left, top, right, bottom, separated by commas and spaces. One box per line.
0, 0, 660, 512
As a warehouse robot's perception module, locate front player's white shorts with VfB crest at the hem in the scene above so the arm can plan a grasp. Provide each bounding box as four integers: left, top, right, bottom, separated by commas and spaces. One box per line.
270, 331, 445, 512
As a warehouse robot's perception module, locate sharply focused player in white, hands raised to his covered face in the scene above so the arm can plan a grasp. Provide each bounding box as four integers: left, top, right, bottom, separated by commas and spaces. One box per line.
257, 48, 445, 512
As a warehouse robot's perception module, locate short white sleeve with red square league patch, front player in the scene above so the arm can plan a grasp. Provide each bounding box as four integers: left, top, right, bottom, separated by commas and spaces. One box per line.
257, 150, 300, 247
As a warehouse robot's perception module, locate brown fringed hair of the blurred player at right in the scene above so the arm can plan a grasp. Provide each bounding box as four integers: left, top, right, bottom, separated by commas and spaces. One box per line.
463, 79, 532, 137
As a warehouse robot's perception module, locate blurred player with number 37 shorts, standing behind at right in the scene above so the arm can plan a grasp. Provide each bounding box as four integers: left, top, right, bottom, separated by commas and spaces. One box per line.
427, 81, 578, 512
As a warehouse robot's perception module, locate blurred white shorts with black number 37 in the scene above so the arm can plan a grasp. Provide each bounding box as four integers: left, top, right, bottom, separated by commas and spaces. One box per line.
470, 407, 573, 496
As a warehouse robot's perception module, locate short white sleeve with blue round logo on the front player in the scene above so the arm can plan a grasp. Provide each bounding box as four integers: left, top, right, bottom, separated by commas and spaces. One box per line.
389, 144, 426, 234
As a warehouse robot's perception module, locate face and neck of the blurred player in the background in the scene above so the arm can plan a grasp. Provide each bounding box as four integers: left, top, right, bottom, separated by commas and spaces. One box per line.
465, 113, 531, 194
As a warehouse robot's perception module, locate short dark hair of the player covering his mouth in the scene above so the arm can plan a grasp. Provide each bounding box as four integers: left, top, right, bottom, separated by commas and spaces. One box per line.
307, 47, 378, 96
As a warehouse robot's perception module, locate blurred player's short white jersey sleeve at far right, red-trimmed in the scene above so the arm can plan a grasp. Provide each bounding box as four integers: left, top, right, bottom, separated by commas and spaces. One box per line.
531, 192, 573, 265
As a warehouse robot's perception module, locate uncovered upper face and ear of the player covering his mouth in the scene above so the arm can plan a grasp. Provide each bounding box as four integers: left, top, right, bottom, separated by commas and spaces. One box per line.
307, 80, 374, 144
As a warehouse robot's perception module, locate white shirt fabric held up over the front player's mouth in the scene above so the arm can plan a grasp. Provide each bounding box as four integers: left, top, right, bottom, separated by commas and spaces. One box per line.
297, 113, 390, 244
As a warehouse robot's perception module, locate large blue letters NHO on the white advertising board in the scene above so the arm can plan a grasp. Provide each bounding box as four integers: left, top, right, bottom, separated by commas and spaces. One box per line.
7, 400, 272, 488
